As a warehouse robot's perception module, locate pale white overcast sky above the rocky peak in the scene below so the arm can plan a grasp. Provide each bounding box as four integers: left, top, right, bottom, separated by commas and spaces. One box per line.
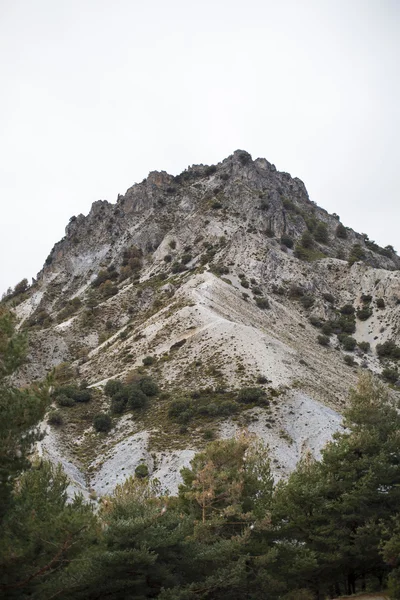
0, 0, 400, 292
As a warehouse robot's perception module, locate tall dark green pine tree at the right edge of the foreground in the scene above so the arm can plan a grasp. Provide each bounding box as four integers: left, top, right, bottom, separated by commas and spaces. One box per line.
273, 376, 400, 594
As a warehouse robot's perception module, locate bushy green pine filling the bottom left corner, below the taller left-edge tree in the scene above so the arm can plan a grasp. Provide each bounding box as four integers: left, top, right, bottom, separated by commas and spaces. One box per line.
0, 462, 96, 600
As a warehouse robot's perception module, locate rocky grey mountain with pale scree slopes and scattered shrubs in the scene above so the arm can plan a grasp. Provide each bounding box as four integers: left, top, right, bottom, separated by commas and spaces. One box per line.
3, 150, 400, 497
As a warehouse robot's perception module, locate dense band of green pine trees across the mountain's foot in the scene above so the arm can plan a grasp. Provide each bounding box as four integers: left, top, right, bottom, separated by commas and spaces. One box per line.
0, 312, 400, 600
